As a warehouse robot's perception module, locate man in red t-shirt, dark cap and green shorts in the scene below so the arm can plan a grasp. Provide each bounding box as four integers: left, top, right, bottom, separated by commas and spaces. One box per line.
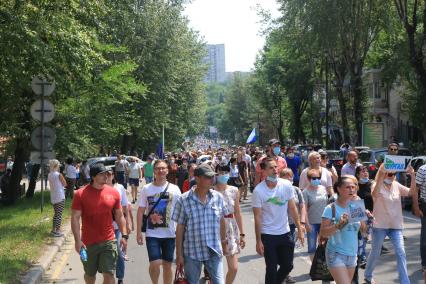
71, 163, 129, 283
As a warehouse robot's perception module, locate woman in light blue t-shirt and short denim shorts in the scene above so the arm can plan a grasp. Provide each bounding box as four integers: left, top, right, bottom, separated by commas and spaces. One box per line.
320, 176, 367, 284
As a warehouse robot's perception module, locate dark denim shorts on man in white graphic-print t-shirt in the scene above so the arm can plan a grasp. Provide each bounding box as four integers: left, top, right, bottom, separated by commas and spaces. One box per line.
146, 237, 176, 262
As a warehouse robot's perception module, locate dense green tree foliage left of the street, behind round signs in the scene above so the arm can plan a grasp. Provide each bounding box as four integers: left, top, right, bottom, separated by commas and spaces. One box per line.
0, 0, 206, 158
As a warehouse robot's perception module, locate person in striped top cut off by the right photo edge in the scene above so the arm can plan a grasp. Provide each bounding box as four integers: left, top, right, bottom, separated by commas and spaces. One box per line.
412, 165, 426, 283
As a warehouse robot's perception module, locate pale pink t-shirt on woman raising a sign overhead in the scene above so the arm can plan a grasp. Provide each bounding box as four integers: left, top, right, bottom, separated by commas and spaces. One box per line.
373, 181, 410, 229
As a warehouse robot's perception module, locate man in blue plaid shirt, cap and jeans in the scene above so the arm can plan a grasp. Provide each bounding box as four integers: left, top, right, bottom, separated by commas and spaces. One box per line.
172, 164, 230, 284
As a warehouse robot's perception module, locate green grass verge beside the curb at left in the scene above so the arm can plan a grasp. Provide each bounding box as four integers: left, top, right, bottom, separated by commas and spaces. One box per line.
0, 192, 71, 284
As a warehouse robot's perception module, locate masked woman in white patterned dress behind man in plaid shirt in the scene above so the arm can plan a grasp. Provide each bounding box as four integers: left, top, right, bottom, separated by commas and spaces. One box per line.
214, 164, 246, 284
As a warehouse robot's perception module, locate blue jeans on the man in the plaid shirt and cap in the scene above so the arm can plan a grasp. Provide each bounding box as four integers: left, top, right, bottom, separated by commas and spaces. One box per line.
184, 251, 225, 284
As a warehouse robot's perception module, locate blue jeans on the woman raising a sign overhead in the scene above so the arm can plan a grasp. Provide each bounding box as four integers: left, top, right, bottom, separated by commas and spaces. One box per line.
364, 228, 410, 284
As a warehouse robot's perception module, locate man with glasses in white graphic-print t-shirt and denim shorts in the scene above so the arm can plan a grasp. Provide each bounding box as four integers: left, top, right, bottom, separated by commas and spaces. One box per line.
136, 160, 181, 284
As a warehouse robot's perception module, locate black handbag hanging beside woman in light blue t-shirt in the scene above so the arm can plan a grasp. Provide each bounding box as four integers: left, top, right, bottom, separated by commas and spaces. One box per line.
309, 203, 336, 281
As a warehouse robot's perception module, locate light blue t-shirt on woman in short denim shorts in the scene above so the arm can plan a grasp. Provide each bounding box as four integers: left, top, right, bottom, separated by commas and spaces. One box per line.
322, 203, 361, 256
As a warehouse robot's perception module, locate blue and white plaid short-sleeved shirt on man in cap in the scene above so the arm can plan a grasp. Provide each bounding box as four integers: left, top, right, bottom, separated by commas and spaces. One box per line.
172, 189, 230, 261
